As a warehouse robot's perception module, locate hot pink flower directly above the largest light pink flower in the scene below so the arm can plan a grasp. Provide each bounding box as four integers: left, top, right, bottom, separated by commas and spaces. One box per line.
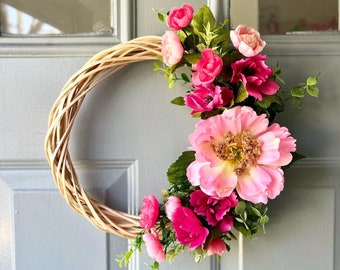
184, 85, 233, 114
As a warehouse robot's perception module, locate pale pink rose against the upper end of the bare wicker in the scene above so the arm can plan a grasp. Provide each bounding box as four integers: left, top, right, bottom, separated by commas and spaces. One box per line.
161, 31, 184, 67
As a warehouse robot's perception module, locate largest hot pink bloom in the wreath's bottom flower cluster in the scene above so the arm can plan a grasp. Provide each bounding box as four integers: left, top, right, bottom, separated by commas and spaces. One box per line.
172, 206, 209, 250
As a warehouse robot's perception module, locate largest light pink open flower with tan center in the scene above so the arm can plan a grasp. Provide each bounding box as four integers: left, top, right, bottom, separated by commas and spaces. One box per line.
187, 106, 296, 203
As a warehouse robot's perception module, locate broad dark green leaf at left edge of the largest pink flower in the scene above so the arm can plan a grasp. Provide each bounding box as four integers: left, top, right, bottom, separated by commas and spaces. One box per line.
167, 151, 195, 185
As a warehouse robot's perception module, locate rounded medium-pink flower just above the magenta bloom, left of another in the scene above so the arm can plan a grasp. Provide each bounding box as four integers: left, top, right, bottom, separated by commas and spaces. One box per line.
192, 49, 223, 86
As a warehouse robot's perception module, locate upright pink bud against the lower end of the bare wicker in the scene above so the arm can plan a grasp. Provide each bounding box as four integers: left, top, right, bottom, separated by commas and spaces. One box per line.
139, 195, 159, 230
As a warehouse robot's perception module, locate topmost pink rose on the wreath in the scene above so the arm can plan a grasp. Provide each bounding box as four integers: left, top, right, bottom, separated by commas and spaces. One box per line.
168, 4, 194, 30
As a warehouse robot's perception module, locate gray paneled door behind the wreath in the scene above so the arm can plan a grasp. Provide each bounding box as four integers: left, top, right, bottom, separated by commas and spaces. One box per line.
0, 0, 340, 270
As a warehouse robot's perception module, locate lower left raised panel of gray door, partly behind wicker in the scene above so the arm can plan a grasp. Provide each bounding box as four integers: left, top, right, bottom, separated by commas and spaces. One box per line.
0, 160, 138, 270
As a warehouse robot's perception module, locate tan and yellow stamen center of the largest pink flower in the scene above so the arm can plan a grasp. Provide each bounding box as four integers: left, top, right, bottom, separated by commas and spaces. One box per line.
212, 132, 261, 176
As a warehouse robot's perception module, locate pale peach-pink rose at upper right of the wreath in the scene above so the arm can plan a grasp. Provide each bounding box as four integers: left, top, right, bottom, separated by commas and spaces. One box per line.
230, 25, 266, 57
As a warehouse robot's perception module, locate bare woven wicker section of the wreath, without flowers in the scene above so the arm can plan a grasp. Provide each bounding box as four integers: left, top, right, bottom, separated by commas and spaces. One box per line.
45, 36, 161, 238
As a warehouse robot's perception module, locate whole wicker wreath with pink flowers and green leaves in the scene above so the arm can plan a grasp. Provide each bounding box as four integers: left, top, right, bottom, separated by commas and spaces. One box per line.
45, 4, 319, 269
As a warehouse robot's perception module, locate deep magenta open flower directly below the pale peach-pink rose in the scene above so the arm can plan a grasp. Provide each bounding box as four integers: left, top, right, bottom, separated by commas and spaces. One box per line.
231, 55, 280, 100
